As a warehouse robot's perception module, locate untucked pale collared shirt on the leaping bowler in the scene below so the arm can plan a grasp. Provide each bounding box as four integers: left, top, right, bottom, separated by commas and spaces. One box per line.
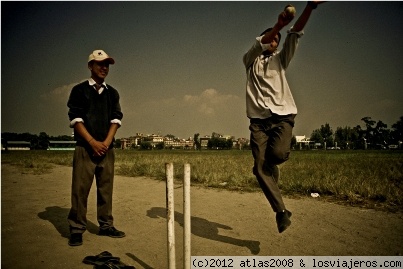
243, 29, 304, 119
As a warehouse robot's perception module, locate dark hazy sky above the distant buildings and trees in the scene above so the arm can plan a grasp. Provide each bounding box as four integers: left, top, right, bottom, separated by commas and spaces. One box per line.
1, 1, 403, 138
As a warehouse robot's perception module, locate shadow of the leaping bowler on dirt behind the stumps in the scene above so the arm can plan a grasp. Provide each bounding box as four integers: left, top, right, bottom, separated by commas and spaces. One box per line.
147, 207, 260, 255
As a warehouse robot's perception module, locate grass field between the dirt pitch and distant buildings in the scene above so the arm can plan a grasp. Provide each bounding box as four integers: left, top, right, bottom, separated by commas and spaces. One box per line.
1, 150, 403, 211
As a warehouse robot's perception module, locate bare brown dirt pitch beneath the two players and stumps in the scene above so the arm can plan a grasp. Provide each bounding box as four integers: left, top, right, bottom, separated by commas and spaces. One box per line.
1, 162, 403, 269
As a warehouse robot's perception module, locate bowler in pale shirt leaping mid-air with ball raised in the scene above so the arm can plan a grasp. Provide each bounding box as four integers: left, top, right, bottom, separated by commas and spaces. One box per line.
243, 1, 326, 233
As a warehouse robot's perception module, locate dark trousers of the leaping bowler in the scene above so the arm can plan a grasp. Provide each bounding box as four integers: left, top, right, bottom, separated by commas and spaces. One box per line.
249, 114, 296, 212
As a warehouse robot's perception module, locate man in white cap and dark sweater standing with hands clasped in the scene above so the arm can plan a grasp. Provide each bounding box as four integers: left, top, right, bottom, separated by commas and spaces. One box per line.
67, 50, 125, 246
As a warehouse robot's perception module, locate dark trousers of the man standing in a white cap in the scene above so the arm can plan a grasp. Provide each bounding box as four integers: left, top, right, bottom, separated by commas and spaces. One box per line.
68, 146, 115, 233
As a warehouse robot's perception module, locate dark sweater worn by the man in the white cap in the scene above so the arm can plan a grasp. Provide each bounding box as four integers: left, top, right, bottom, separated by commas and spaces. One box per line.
67, 81, 123, 147
